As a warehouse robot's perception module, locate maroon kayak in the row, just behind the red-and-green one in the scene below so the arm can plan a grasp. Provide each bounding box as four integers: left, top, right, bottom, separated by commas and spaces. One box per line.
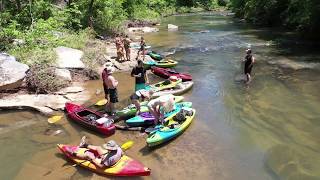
151, 67, 192, 81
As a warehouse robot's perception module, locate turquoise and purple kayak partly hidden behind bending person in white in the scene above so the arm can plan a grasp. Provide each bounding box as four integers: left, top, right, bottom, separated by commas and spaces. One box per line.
126, 102, 192, 127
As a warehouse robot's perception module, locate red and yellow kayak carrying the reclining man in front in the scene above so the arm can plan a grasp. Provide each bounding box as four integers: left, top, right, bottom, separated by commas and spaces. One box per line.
58, 144, 151, 176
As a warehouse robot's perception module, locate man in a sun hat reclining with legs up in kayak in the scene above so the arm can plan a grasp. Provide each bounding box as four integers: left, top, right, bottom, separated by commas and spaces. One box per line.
67, 136, 123, 168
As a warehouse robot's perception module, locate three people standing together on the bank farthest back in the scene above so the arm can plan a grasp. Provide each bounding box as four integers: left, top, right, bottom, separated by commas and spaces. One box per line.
115, 34, 146, 62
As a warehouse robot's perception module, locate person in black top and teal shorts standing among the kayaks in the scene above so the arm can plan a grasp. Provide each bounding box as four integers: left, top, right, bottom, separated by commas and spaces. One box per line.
131, 60, 149, 91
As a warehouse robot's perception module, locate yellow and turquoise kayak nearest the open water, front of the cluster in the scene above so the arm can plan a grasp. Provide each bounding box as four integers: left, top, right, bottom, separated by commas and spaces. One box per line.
147, 109, 196, 147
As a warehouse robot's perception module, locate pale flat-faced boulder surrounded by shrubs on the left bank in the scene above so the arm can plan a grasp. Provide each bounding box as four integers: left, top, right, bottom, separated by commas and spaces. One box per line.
55, 46, 85, 69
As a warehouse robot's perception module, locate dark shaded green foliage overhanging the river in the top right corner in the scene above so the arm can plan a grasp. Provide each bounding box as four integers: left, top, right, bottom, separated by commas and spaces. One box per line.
231, 0, 320, 36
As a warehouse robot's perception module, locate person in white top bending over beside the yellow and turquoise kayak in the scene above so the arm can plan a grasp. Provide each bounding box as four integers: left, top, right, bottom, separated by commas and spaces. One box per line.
147, 94, 175, 124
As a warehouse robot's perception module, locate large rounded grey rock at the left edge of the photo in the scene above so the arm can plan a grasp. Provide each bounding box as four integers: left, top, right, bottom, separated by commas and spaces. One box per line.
0, 53, 29, 90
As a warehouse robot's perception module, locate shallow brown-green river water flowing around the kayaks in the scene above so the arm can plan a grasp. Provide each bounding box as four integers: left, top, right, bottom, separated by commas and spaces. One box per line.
0, 14, 320, 180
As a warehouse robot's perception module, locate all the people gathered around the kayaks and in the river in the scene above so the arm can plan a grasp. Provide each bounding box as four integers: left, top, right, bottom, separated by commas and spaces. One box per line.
69, 36, 255, 168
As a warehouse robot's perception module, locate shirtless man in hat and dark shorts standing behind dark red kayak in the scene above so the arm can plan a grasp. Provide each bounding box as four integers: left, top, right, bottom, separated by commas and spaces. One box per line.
102, 64, 119, 115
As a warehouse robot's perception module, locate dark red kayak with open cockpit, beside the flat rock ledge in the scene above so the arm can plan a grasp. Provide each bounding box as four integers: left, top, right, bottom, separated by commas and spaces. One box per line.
65, 103, 116, 136
